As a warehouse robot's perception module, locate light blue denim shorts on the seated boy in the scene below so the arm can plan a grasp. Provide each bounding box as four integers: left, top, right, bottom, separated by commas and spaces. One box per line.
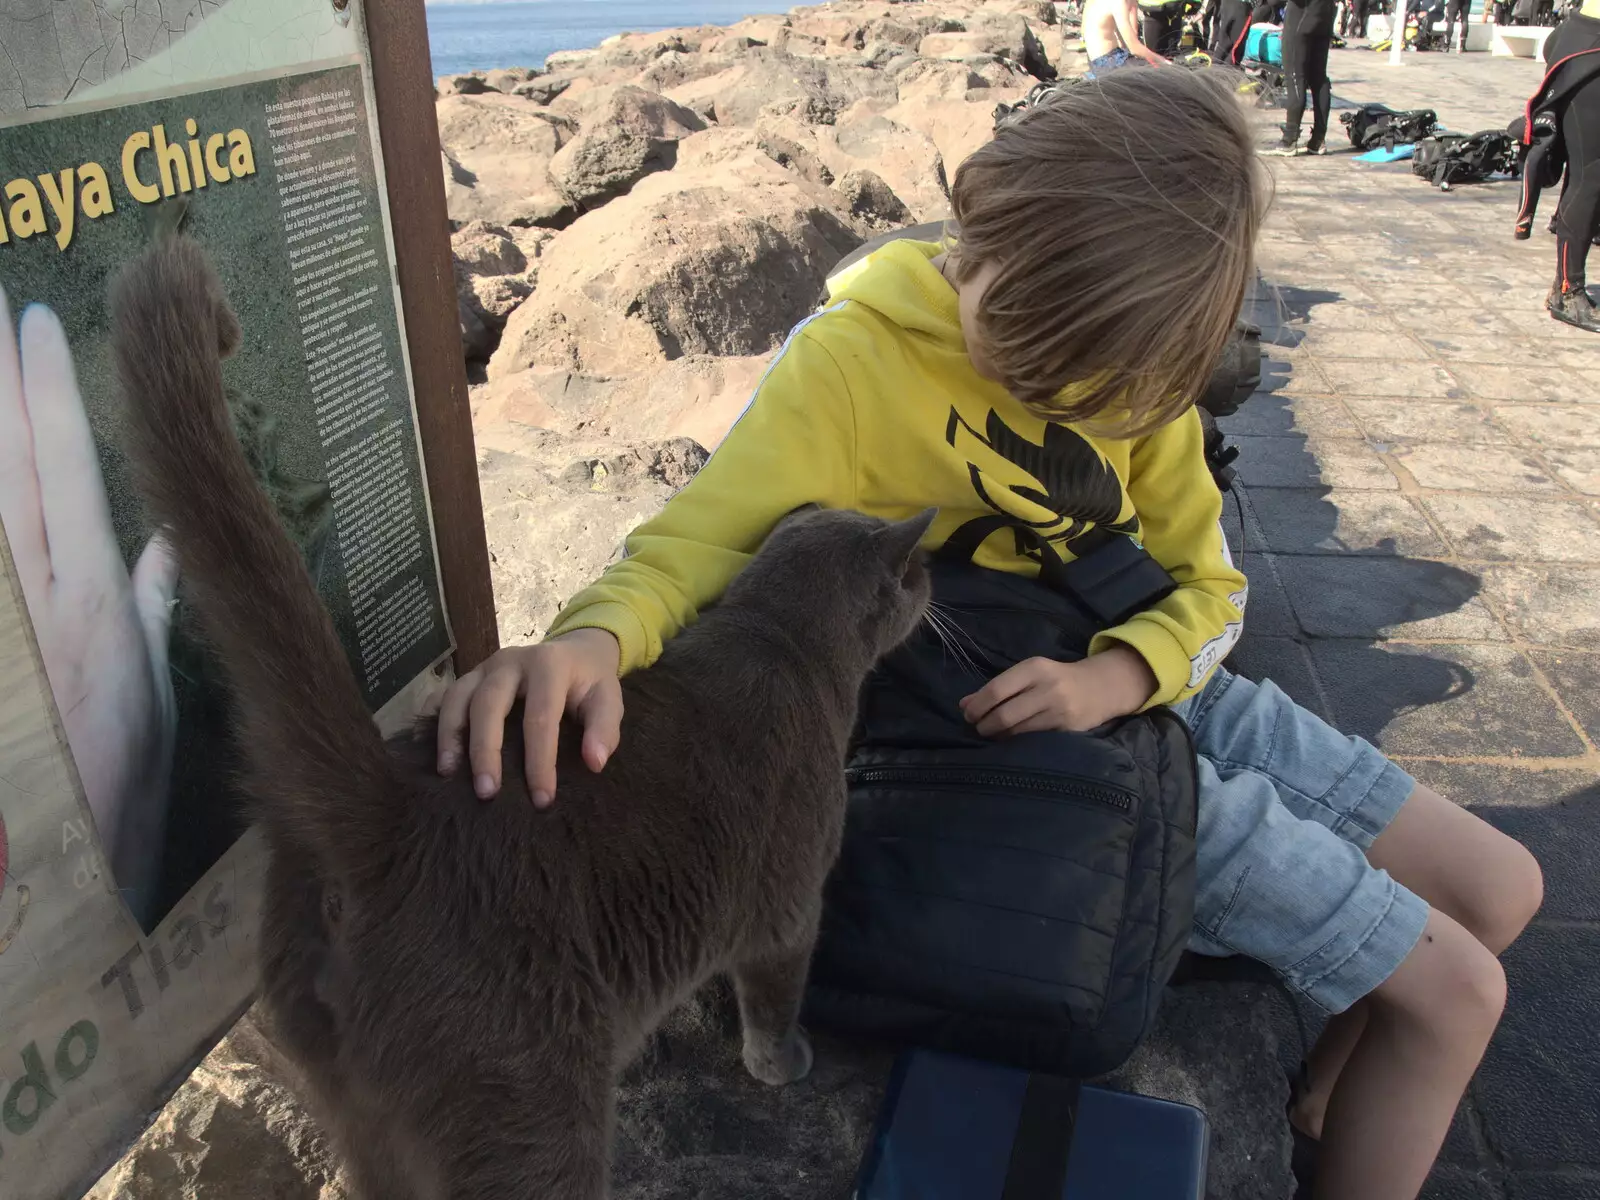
1174, 669, 1429, 1013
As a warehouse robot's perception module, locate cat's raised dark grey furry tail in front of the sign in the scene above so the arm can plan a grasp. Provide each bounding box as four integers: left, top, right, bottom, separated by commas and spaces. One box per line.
110, 235, 392, 866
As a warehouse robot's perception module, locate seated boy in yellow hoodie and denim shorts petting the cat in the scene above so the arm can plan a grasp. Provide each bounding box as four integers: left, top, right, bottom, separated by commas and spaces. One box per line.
438, 70, 1541, 1200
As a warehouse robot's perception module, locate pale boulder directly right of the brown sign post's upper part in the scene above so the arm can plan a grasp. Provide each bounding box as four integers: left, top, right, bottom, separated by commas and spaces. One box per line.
435, 93, 578, 227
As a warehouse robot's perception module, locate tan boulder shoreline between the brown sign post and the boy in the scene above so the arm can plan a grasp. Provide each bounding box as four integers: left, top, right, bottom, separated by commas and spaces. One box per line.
437, 0, 1080, 640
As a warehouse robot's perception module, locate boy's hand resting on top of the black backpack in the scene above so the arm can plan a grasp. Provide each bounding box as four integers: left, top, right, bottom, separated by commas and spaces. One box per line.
962, 646, 1155, 738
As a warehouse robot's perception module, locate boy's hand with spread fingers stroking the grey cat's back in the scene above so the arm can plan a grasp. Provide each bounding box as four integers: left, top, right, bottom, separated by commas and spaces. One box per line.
438, 629, 622, 808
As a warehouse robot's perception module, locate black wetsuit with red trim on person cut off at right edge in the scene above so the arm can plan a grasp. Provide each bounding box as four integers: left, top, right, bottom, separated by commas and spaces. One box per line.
1517, 13, 1600, 291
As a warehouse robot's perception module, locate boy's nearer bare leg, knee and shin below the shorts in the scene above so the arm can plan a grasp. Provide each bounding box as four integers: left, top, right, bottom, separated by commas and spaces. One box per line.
1312, 909, 1506, 1200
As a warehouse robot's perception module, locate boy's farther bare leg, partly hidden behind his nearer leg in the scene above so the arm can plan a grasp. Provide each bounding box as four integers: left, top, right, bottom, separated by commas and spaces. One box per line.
1290, 784, 1544, 1138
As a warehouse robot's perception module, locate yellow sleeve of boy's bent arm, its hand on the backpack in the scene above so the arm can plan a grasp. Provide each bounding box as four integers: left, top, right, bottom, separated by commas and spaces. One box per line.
1090, 411, 1250, 706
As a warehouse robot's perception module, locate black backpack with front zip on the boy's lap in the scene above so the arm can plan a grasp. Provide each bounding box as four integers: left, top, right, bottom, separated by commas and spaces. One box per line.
805, 553, 1198, 1077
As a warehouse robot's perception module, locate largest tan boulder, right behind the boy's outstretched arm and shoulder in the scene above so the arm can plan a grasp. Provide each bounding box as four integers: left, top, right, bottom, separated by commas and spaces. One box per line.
488, 130, 864, 379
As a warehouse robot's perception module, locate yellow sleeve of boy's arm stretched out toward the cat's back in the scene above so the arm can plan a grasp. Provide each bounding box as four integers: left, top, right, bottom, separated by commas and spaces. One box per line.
549, 330, 856, 674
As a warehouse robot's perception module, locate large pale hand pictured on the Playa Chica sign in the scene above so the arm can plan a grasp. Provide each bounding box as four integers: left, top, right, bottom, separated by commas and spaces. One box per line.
0, 291, 178, 914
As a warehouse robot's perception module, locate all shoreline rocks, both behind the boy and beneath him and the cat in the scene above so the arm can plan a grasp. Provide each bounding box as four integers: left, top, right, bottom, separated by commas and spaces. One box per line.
91, 0, 1298, 1200
